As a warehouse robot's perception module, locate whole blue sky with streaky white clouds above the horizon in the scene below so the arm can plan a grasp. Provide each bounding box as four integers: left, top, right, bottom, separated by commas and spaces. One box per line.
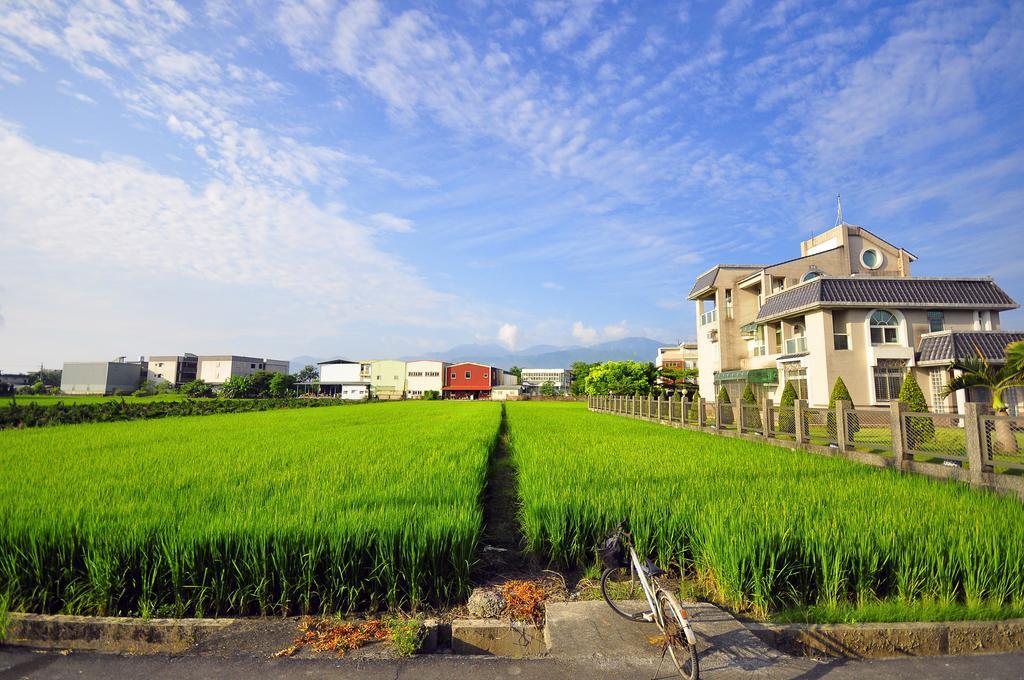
0, 0, 1024, 370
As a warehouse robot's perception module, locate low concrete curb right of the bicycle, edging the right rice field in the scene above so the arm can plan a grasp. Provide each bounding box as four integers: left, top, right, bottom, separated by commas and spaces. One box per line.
746, 619, 1024, 658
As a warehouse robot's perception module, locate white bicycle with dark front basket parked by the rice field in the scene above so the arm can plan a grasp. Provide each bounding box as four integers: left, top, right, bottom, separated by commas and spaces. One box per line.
600, 519, 700, 680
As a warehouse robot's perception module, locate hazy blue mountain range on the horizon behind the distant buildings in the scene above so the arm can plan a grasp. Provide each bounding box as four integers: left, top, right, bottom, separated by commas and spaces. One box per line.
291, 337, 667, 373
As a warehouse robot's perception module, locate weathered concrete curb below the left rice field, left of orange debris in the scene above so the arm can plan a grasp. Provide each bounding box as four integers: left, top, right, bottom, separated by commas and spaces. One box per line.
3, 612, 237, 653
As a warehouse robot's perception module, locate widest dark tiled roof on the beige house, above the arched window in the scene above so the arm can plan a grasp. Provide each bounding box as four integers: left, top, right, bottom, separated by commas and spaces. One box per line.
758, 277, 1018, 321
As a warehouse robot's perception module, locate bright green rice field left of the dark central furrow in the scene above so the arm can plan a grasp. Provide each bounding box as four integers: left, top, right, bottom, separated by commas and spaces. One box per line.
0, 402, 501, 617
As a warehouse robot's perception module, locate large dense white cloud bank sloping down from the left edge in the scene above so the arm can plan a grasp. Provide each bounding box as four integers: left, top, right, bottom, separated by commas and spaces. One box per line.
0, 121, 458, 328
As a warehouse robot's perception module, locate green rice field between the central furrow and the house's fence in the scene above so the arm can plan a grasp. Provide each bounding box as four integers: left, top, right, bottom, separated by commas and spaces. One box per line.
507, 402, 1024, 621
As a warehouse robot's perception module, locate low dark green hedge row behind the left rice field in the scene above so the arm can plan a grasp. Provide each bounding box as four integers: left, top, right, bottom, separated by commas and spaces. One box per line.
0, 398, 352, 429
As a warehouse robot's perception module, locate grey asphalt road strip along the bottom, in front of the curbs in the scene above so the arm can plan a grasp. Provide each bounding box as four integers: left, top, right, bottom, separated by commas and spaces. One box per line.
6, 647, 1024, 680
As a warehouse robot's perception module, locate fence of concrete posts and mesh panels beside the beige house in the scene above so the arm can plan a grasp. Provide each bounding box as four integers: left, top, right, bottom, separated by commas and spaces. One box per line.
587, 394, 1024, 501
